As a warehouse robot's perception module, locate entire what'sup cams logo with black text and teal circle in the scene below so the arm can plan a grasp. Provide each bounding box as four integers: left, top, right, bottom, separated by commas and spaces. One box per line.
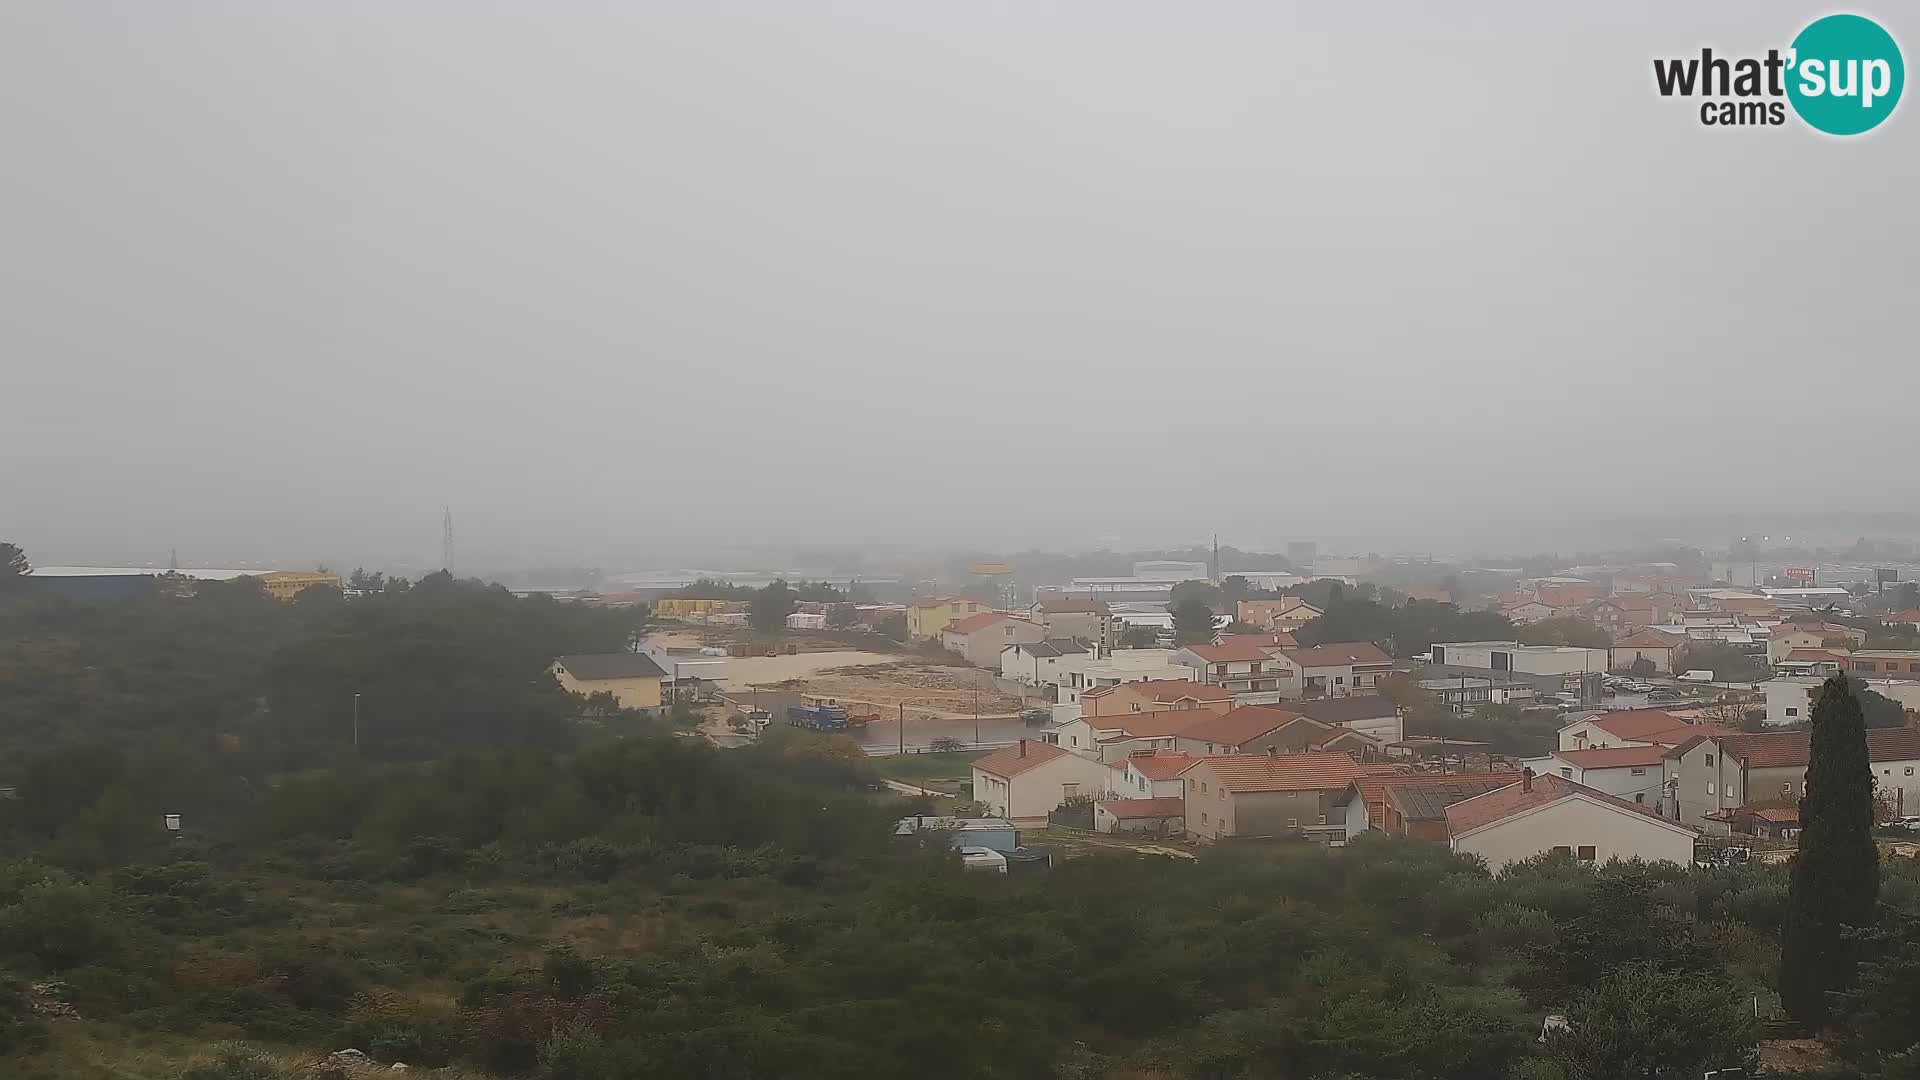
1653, 15, 1907, 135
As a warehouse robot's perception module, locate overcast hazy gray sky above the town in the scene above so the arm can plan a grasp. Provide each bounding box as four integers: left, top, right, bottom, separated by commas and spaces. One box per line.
0, 0, 1920, 565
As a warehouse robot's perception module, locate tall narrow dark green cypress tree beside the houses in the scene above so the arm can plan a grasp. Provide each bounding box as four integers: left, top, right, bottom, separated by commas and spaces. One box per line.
1780, 675, 1880, 1024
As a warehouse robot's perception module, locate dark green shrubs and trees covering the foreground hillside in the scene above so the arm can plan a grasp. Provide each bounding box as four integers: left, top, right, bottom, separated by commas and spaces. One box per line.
0, 557, 1920, 1080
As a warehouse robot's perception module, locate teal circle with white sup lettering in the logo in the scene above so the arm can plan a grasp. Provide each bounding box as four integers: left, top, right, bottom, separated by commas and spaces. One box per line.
1788, 15, 1907, 135
